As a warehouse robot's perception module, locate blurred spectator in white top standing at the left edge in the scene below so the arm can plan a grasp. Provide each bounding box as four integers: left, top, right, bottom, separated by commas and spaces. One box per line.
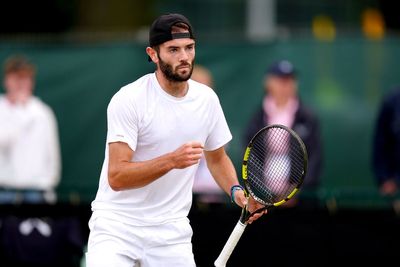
0, 56, 61, 204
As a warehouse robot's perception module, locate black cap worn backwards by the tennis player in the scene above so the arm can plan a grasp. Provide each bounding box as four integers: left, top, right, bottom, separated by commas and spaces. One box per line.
149, 14, 195, 46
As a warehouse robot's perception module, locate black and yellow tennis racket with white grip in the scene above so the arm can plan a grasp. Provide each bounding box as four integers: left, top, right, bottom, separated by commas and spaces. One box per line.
214, 124, 308, 267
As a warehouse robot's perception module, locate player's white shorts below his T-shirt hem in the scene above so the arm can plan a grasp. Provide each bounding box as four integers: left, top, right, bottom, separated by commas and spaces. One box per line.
86, 217, 196, 267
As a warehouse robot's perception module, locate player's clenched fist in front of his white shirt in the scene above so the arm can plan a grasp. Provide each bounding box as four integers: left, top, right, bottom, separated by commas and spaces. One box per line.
171, 142, 204, 169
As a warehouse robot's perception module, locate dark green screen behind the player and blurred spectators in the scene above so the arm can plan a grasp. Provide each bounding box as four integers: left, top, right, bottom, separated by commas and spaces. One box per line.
0, 38, 400, 207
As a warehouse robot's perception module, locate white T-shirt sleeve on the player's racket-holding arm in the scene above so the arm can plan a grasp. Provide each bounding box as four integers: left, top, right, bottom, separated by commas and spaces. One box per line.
204, 93, 232, 151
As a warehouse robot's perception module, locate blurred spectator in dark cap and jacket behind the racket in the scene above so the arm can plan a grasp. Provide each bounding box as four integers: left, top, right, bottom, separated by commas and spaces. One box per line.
245, 60, 322, 205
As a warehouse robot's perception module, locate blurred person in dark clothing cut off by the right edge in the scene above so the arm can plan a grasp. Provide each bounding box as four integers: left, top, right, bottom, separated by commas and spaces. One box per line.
373, 88, 400, 195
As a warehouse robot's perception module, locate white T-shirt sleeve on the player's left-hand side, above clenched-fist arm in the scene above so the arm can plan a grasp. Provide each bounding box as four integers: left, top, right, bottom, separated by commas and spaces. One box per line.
107, 91, 139, 150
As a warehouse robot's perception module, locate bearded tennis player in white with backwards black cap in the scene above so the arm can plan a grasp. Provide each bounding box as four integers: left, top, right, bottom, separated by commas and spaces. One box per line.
86, 14, 261, 267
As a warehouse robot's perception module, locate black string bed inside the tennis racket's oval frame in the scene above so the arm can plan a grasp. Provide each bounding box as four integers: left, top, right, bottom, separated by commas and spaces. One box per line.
247, 127, 305, 204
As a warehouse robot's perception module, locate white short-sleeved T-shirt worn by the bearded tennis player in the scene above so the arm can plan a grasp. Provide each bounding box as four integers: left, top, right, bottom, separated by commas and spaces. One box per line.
92, 73, 232, 225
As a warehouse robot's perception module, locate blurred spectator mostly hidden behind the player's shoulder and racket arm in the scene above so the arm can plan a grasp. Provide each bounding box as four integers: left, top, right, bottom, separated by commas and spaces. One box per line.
191, 65, 225, 203
